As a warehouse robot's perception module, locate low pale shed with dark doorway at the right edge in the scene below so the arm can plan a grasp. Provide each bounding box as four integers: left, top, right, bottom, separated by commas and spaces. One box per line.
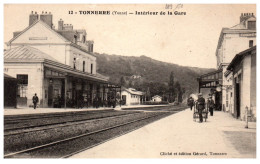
225, 46, 256, 120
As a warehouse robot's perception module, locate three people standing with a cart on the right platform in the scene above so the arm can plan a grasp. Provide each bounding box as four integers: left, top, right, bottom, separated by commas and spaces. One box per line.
187, 93, 215, 122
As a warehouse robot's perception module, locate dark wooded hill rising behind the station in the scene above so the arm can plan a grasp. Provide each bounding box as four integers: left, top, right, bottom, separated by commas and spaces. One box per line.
96, 53, 215, 100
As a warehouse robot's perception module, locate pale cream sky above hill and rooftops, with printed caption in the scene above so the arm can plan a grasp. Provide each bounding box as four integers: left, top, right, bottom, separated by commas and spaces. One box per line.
4, 4, 256, 68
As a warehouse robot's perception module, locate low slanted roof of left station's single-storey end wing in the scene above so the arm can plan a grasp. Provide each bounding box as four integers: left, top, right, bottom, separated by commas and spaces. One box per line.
4, 46, 58, 62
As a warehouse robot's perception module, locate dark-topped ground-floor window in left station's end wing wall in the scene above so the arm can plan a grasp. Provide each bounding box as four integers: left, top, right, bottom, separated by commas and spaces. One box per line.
17, 75, 28, 97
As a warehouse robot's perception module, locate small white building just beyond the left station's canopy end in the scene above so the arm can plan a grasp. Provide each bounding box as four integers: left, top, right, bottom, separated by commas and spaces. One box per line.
121, 88, 143, 105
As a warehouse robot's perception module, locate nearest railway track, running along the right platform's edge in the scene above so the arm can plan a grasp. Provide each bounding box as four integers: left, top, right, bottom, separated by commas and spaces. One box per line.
4, 112, 173, 158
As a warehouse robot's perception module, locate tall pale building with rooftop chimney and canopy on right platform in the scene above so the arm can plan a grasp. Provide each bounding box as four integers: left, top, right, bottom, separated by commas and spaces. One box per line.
198, 13, 256, 118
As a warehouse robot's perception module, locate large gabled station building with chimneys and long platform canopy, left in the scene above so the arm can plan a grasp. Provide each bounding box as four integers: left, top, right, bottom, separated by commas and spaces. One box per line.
4, 12, 109, 107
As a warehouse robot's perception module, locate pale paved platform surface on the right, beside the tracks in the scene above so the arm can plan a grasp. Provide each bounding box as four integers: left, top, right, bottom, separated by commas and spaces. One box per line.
71, 109, 256, 158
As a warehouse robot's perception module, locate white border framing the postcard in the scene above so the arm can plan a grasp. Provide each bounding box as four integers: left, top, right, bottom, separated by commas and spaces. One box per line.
0, 0, 260, 164
